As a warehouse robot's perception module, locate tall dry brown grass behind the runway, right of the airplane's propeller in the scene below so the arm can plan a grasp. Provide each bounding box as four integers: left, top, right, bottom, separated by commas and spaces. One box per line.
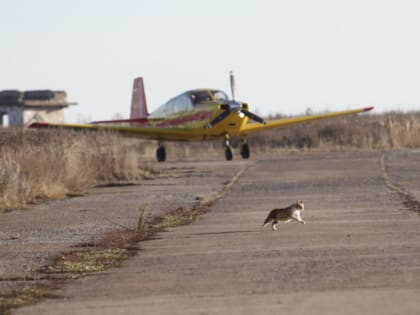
249, 112, 420, 151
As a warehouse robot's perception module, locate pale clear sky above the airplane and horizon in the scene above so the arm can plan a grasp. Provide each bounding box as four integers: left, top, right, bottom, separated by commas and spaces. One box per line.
0, 0, 420, 122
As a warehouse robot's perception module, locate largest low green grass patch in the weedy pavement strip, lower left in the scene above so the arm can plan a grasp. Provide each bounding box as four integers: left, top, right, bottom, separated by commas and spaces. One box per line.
46, 248, 129, 273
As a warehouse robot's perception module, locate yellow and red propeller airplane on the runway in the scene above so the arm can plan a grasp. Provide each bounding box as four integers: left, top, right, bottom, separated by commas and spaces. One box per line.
30, 71, 373, 162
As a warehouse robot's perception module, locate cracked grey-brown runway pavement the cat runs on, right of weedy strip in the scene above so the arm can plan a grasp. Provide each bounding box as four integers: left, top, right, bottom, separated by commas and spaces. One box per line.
5, 151, 420, 314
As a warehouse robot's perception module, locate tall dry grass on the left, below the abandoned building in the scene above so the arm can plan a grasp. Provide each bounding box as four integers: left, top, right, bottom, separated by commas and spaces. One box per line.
0, 128, 153, 210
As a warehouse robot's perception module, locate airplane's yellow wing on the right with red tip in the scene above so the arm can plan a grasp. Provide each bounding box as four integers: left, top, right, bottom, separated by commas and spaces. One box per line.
240, 107, 373, 136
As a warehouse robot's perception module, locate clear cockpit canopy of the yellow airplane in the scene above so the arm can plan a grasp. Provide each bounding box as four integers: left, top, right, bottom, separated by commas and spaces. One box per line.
149, 89, 229, 119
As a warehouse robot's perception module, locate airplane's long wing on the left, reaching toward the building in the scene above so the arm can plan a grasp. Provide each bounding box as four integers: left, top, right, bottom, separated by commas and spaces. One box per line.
30, 122, 204, 141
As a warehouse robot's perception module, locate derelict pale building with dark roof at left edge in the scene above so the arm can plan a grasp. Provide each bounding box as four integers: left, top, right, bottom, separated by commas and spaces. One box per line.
0, 90, 77, 127
